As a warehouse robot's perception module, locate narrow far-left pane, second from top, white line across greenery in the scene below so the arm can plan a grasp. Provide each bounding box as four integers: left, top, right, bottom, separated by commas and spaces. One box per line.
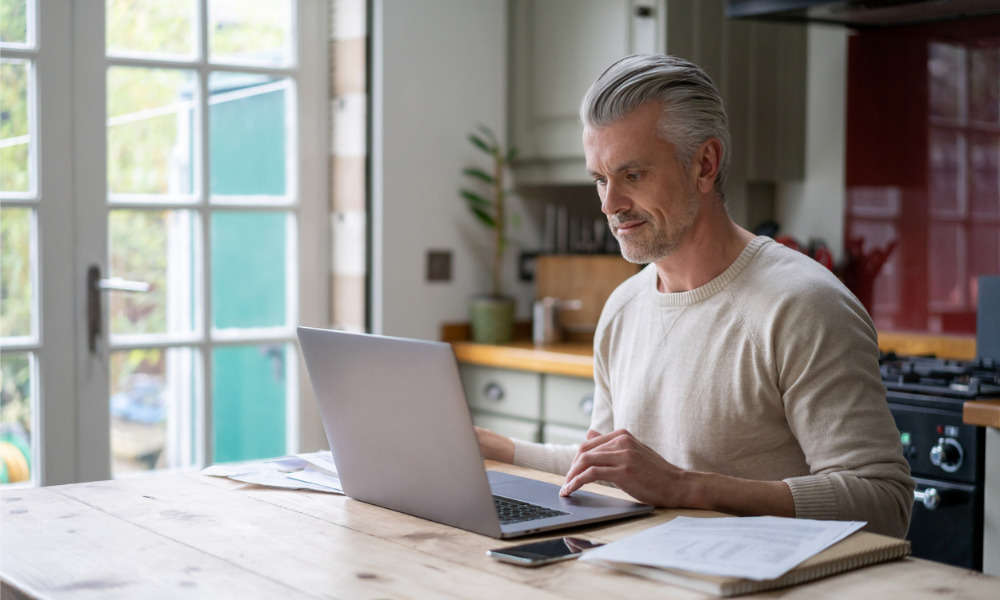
0, 59, 32, 192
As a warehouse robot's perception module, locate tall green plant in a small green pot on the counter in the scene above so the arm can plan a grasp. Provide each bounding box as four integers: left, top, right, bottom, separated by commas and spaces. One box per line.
460, 125, 517, 344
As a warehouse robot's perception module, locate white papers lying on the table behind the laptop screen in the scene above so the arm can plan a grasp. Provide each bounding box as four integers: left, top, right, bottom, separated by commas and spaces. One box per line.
201, 450, 344, 494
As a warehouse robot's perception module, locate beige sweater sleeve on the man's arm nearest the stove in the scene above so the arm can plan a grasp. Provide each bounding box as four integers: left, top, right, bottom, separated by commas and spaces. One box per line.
771, 274, 914, 537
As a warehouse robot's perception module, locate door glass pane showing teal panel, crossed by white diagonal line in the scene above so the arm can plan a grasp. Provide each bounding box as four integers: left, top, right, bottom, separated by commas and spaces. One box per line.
209, 73, 291, 202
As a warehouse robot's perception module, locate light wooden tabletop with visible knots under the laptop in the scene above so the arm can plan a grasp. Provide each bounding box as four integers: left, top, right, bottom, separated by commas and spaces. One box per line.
0, 463, 1000, 600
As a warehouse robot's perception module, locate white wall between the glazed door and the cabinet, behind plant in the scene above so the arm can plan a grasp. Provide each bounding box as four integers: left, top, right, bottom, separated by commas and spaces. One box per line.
371, 0, 533, 339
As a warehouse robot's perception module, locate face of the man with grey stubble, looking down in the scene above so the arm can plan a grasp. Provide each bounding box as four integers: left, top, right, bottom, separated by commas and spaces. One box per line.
583, 103, 701, 264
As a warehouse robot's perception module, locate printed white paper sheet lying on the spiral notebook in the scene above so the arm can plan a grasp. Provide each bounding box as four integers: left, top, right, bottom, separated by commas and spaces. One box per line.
581, 517, 865, 580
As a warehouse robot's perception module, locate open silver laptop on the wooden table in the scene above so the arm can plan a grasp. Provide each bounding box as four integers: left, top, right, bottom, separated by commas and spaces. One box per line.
298, 327, 653, 538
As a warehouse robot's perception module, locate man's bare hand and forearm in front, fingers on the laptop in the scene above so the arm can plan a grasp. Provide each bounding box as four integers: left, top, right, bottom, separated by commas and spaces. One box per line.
560, 429, 795, 517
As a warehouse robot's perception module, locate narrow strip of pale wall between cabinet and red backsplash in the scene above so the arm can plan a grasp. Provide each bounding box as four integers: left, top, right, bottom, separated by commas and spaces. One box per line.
775, 25, 849, 261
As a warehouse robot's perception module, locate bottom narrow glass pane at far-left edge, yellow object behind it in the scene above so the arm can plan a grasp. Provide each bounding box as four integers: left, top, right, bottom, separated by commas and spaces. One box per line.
0, 352, 35, 483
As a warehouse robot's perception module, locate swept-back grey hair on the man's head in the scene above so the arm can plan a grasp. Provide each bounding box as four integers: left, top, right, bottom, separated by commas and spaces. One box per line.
580, 54, 732, 197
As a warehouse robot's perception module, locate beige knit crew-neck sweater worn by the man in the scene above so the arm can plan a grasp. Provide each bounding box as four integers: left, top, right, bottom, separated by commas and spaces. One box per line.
514, 237, 914, 537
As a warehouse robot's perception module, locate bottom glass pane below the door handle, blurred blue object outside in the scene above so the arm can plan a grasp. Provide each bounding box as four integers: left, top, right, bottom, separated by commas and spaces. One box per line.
111, 348, 202, 475
